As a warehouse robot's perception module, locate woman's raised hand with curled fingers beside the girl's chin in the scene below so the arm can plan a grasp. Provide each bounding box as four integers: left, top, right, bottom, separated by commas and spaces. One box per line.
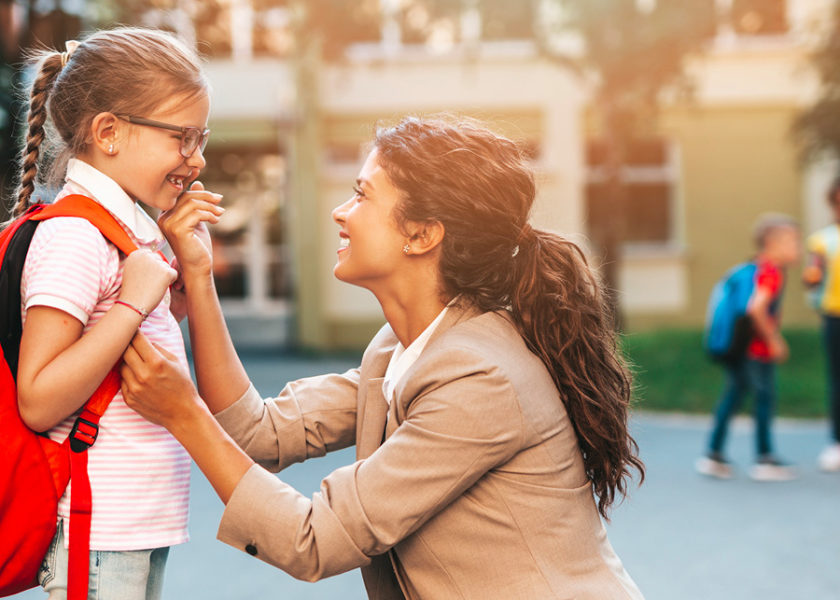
158, 181, 225, 274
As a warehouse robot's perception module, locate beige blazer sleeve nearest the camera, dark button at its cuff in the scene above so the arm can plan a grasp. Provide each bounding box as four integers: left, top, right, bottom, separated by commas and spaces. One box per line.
218, 349, 523, 581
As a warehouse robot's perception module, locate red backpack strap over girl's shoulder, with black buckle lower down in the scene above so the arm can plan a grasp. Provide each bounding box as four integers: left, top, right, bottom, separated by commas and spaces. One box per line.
30, 195, 137, 600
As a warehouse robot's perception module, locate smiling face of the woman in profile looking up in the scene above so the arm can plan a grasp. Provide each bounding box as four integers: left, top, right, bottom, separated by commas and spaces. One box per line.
332, 150, 407, 292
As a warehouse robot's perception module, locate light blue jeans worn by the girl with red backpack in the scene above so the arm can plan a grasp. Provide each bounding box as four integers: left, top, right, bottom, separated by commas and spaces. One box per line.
38, 522, 169, 600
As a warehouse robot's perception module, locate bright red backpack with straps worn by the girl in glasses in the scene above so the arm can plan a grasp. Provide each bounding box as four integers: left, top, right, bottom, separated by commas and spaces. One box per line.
0, 195, 137, 600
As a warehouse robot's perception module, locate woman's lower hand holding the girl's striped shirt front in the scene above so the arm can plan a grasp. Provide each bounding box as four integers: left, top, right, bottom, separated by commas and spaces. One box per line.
120, 332, 207, 433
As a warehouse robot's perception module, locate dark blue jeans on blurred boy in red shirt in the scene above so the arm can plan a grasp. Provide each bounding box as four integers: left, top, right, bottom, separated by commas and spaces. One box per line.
709, 359, 776, 455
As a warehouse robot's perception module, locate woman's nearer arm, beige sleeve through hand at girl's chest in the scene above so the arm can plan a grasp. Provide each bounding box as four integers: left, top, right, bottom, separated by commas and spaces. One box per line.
123, 336, 522, 581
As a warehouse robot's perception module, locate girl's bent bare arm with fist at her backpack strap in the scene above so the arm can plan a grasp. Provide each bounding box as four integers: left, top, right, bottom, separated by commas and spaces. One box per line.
17, 250, 175, 431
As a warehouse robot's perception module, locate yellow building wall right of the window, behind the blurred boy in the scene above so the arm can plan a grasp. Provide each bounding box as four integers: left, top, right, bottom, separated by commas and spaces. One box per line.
629, 105, 815, 328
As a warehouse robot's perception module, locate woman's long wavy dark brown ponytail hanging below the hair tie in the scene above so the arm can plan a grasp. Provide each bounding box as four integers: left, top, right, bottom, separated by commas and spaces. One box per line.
510, 225, 644, 518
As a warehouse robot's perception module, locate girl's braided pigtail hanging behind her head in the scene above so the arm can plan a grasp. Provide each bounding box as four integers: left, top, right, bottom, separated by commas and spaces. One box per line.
12, 52, 62, 217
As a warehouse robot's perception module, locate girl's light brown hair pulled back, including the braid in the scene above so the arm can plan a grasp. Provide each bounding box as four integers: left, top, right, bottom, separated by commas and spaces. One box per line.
12, 27, 209, 217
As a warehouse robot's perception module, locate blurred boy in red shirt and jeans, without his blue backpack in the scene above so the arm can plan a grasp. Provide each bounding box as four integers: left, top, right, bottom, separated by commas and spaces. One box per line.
696, 215, 801, 481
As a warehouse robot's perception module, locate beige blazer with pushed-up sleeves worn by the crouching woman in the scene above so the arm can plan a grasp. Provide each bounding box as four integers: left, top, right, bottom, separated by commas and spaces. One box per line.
216, 306, 642, 600
